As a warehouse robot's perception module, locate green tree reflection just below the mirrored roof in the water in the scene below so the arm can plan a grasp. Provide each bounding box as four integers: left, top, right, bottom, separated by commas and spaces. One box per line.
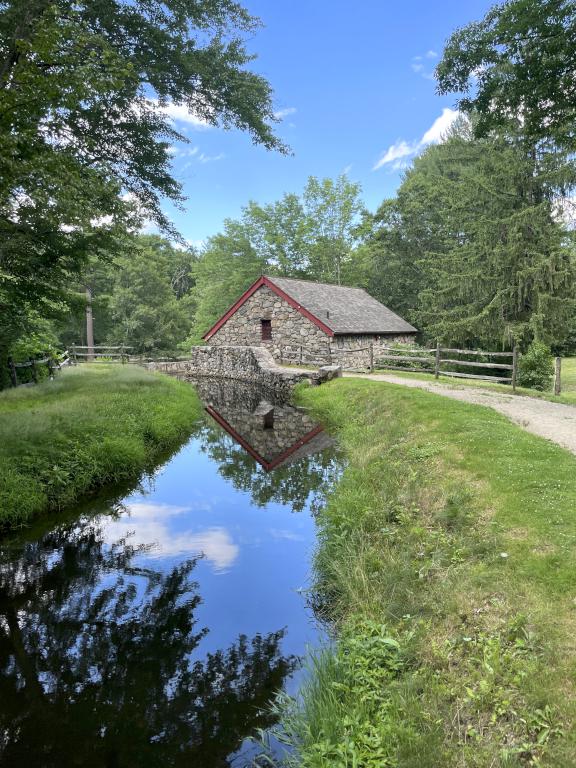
199, 422, 341, 512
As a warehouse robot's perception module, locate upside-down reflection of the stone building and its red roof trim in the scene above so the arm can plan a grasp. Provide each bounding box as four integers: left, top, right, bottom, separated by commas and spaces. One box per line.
195, 379, 334, 472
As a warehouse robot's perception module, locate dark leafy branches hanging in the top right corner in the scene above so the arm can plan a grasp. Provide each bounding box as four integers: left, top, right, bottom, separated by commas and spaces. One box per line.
436, 0, 576, 151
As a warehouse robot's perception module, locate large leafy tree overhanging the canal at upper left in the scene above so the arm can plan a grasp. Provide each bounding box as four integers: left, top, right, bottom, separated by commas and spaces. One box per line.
0, 0, 284, 376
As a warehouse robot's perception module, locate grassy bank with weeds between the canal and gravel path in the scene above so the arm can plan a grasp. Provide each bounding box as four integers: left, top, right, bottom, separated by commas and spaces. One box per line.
278, 379, 576, 768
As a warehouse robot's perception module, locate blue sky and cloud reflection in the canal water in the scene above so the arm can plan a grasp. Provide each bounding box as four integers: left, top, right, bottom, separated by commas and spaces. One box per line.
104, 427, 319, 654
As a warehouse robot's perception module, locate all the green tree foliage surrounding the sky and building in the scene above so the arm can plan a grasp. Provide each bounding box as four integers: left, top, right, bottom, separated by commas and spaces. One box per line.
0, 0, 576, 376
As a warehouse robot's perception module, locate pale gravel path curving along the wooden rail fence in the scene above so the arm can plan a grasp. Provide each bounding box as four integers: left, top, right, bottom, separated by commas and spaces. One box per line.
344, 373, 576, 454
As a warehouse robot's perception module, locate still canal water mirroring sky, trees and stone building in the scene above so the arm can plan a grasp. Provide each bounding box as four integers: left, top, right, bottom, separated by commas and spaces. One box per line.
0, 382, 341, 768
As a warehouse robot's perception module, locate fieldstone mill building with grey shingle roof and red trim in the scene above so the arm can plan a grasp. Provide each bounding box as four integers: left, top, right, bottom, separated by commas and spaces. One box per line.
203, 275, 418, 368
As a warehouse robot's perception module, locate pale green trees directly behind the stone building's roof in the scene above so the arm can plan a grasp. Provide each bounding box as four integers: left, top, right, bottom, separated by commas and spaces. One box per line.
189, 176, 364, 342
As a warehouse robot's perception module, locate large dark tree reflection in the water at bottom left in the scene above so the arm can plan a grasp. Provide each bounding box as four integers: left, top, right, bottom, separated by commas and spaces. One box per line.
0, 520, 295, 768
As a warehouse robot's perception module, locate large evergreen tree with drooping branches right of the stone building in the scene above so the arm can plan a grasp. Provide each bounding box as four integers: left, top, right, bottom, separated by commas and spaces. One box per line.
362, 122, 574, 347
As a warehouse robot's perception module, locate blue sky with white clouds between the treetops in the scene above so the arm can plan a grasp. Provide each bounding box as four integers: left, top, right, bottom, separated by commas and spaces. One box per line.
161, 0, 492, 243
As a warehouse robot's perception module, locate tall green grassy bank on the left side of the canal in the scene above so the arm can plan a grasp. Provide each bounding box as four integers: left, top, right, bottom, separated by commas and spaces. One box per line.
0, 365, 199, 528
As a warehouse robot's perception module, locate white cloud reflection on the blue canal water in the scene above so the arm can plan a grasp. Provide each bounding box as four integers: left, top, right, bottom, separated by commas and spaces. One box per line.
103, 502, 239, 573
